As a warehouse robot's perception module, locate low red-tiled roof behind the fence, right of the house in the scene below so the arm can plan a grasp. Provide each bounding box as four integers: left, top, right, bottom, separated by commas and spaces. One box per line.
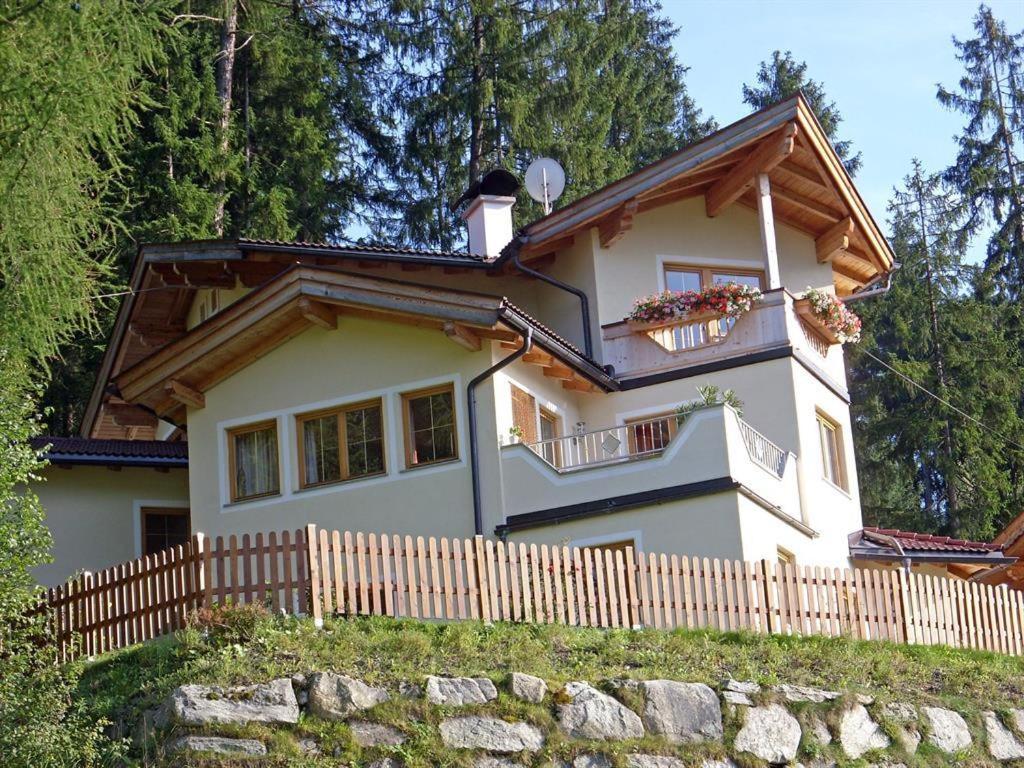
850, 526, 1017, 565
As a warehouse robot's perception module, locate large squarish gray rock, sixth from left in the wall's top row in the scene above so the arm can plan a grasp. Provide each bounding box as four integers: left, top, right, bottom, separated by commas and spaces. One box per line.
640, 680, 722, 744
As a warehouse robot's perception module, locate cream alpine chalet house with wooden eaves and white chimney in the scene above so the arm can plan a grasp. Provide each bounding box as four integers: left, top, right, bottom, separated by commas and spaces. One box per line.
39, 96, 950, 583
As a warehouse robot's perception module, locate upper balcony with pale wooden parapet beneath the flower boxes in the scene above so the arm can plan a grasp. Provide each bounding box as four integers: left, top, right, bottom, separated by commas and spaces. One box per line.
603, 289, 845, 382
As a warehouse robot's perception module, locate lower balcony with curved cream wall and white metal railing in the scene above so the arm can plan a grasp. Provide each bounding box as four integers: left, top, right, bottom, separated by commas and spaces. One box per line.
501, 404, 803, 526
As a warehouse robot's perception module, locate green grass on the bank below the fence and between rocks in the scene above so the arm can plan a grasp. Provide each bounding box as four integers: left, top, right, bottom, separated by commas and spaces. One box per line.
78, 611, 1024, 768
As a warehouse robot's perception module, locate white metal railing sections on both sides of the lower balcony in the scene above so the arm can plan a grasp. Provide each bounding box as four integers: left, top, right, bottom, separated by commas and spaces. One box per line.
526, 414, 790, 477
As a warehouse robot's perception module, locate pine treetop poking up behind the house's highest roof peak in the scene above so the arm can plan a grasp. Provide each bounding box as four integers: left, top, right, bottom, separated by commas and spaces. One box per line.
743, 50, 861, 176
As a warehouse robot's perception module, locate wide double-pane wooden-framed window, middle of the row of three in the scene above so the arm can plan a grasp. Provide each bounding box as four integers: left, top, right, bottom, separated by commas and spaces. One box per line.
296, 399, 386, 488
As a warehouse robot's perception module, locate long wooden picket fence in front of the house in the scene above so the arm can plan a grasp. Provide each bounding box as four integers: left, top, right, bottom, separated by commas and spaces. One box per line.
47, 525, 1024, 658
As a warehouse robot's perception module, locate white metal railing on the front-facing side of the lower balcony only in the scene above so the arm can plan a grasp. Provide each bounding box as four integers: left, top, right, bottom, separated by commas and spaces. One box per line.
526, 414, 676, 472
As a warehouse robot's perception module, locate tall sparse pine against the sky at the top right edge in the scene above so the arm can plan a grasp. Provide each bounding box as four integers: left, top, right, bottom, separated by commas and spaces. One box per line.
937, 5, 1024, 298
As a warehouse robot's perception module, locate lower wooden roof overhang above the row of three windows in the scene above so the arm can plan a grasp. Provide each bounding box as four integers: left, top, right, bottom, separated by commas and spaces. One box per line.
109, 265, 616, 423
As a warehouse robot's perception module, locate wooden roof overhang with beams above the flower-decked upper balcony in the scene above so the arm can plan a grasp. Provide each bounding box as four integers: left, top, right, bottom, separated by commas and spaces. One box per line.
512, 94, 895, 295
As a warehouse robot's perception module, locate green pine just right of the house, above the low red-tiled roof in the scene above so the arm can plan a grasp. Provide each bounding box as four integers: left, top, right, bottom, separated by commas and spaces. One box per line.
850, 161, 1024, 539
